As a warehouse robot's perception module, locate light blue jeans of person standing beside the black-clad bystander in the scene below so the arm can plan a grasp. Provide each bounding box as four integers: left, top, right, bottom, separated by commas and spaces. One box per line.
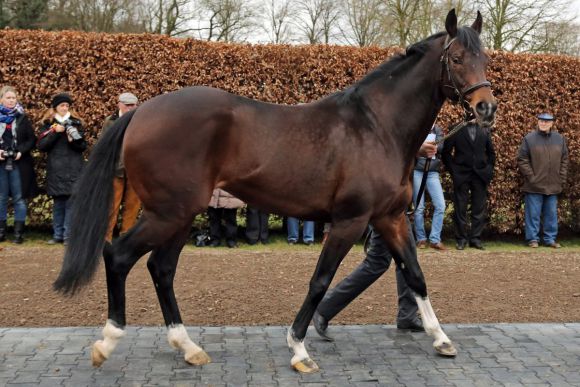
413, 171, 445, 243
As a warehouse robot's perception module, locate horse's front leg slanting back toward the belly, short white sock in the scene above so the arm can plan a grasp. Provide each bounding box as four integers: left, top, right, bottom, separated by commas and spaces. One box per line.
287, 217, 368, 373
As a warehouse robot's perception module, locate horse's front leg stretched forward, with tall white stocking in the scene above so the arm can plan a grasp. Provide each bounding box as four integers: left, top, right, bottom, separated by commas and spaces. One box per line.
373, 214, 457, 356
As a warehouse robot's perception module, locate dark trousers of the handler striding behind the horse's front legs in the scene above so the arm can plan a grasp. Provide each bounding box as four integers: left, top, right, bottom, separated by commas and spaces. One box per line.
317, 227, 418, 322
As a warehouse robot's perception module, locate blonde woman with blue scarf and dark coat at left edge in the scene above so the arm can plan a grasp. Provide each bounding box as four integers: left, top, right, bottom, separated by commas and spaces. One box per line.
0, 86, 37, 244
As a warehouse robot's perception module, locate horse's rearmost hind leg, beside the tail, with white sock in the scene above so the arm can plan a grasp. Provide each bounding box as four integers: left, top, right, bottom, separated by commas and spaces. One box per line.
91, 212, 182, 367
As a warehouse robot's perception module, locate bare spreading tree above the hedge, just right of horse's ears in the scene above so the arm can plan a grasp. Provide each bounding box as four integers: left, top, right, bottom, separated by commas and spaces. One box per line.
475, 0, 573, 52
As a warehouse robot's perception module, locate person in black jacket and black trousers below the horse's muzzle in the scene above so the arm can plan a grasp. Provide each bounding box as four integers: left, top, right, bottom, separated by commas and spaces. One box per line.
442, 123, 495, 250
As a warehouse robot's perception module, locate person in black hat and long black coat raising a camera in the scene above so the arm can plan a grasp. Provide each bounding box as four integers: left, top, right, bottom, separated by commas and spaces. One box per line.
37, 93, 87, 244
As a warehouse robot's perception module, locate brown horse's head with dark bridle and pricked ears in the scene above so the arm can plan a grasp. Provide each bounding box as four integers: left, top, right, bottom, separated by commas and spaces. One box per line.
441, 9, 497, 127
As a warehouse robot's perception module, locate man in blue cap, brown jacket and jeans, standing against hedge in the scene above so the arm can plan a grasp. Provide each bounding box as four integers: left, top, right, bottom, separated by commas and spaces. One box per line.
518, 113, 568, 249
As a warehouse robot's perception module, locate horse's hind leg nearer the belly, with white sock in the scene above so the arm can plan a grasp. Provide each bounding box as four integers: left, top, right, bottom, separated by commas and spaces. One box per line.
147, 222, 211, 365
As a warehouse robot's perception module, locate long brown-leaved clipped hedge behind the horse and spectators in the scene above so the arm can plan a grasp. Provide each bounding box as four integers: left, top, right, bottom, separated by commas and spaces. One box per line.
0, 30, 580, 232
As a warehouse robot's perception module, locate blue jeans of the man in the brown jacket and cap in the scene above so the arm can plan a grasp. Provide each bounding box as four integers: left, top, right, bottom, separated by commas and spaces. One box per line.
524, 193, 558, 244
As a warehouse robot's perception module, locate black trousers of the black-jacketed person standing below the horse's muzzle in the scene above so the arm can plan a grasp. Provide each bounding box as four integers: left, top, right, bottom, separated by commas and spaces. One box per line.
453, 176, 487, 242
